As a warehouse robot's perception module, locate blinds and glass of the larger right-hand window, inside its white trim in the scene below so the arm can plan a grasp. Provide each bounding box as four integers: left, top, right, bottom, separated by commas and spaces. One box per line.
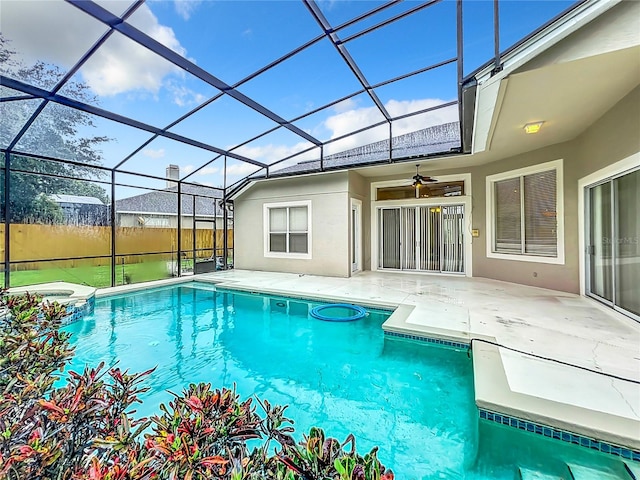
493, 169, 558, 257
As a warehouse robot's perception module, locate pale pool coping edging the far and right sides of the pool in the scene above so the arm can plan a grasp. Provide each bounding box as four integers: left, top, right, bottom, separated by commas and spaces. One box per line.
41, 275, 640, 461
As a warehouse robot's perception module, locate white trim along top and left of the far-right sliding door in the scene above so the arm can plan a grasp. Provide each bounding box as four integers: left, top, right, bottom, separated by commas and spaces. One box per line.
578, 152, 640, 295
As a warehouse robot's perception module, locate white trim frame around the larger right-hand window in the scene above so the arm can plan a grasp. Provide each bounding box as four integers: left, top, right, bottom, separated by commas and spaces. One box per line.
485, 159, 565, 265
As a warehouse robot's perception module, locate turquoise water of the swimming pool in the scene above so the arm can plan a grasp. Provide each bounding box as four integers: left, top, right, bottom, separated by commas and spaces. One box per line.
65, 283, 619, 480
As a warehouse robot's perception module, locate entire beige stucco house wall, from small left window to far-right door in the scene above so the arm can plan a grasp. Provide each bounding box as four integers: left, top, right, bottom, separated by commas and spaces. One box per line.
235, 87, 640, 293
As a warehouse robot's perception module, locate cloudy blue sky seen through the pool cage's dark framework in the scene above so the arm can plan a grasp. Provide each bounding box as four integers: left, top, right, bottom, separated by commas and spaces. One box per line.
0, 0, 573, 196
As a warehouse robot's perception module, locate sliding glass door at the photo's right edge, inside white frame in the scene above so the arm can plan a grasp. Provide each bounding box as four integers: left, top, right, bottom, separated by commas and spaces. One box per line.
585, 170, 640, 320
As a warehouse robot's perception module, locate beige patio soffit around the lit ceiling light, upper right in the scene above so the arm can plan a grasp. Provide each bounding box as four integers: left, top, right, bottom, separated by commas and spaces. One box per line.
489, 46, 640, 157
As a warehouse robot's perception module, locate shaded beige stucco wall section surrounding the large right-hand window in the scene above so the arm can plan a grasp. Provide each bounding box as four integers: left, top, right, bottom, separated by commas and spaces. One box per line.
471, 87, 640, 293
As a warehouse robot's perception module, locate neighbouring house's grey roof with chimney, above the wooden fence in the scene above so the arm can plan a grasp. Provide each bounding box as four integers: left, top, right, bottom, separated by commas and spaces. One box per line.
116, 184, 223, 216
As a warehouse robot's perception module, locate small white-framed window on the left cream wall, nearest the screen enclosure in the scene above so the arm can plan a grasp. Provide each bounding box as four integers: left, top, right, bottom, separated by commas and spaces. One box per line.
264, 202, 311, 258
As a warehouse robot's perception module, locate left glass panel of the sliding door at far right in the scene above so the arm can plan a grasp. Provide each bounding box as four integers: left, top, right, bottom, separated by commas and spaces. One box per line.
587, 182, 613, 302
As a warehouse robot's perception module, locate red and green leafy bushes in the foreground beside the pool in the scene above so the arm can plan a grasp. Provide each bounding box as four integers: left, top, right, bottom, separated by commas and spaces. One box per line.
0, 292, 393, 480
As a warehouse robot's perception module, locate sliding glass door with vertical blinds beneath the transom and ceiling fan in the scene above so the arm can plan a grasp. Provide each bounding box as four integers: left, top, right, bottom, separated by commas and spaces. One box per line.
378, 205, 464, 273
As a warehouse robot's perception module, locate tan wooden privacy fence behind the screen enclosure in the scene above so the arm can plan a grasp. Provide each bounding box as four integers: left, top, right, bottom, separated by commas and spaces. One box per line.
0, 224, 233, 270
